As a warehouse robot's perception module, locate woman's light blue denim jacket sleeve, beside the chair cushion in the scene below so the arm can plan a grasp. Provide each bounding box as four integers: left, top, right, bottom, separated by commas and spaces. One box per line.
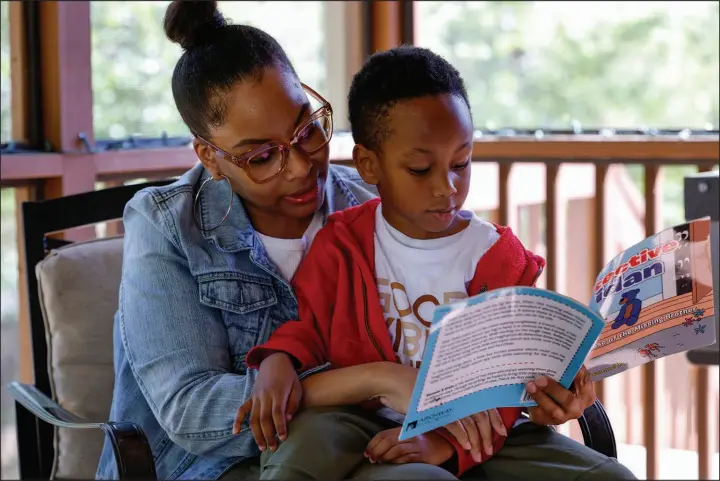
119, 193, 257, 456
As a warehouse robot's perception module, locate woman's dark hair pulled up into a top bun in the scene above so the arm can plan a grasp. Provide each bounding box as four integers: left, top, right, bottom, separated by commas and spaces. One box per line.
163, 0, 295, 138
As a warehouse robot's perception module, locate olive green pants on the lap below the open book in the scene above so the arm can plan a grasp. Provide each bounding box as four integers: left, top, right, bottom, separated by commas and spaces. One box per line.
222, 407, 636, 481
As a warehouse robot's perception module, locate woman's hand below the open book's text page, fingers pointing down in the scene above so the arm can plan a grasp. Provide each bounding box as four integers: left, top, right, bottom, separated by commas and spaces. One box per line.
445, 409, 507, 463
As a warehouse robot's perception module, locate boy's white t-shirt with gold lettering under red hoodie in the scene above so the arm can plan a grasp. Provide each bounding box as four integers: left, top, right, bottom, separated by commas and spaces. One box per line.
375, 205, 500, 368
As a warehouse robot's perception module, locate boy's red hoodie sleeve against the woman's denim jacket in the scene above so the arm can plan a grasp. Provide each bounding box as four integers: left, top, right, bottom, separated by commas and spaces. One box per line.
246, 225, 338, 372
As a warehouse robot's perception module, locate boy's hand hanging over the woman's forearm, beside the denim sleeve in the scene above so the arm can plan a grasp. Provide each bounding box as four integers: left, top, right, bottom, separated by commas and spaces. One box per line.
233, 353, 302, 451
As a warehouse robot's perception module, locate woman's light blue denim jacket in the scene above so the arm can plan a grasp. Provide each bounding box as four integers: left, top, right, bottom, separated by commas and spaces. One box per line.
97, 164, 376, 479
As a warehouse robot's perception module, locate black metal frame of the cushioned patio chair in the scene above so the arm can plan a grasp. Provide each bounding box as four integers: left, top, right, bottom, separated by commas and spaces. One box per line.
7, 181, 617, 480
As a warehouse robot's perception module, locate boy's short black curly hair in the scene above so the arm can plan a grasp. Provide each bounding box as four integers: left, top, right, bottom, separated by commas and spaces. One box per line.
348, 46, 470, 150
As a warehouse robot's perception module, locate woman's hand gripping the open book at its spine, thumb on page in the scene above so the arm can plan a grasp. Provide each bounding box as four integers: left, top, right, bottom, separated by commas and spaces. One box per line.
526, 366, 597, 426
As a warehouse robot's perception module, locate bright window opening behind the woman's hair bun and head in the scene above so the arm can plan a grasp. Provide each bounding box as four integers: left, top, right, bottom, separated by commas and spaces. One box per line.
91, 1, 326, 139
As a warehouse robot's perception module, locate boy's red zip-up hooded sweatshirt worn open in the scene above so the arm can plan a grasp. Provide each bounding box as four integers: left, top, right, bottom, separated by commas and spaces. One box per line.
247, 199, 545, 476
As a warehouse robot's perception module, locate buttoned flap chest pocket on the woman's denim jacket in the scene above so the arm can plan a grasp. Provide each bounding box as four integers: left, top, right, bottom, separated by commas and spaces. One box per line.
198, 272, 277, 374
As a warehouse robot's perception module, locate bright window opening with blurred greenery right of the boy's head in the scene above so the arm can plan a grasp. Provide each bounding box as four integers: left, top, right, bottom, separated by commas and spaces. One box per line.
415, 1, 720, 129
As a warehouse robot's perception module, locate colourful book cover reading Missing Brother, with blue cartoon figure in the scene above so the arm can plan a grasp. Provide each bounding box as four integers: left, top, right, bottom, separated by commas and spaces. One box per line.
585, 218, 716, 381
